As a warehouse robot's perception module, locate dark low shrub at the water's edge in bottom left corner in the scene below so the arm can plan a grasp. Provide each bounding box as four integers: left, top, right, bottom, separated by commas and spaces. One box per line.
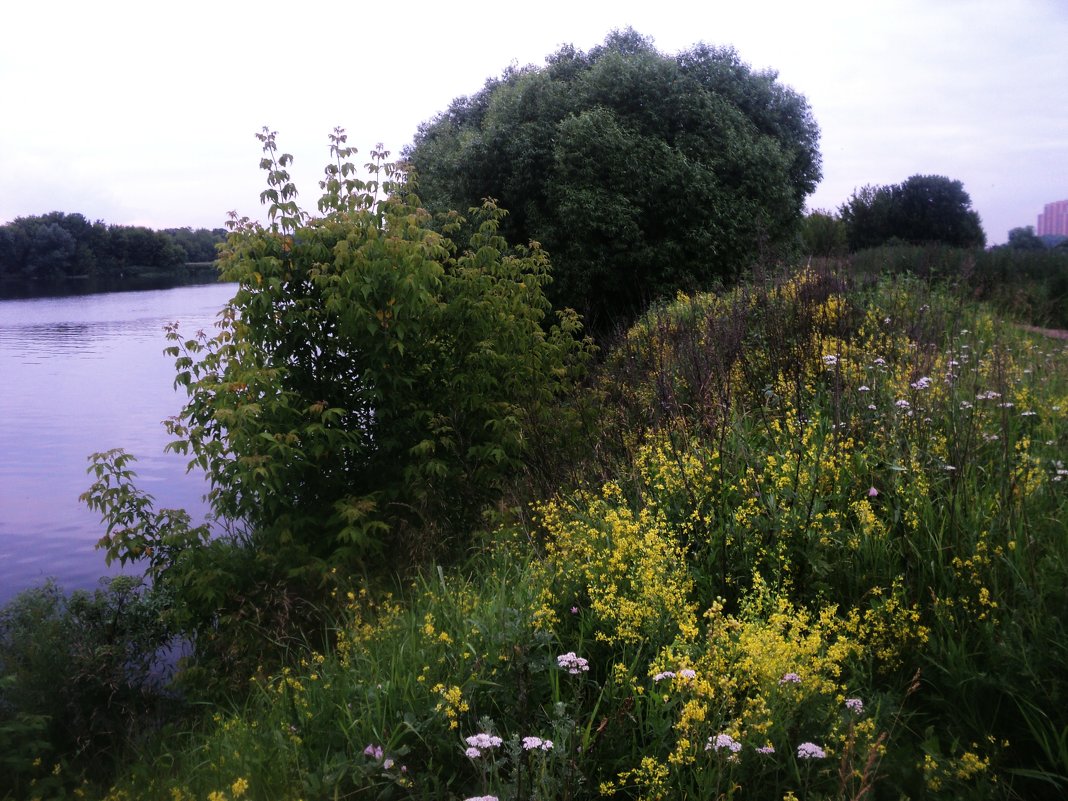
0, 577, 172, 798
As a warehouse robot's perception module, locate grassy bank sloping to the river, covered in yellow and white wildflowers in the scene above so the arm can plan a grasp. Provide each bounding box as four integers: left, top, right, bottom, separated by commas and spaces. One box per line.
0, 260, 1068, 801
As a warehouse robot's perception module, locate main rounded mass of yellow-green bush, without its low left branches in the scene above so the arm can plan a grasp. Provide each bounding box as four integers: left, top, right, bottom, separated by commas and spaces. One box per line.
165, 134, 583, 569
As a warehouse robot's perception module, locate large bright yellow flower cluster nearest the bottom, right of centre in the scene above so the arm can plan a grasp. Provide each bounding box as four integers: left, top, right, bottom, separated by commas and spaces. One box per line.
619, 576, 876, 799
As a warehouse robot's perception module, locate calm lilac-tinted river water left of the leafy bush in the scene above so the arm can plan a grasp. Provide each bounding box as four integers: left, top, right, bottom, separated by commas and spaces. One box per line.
0, 284, 235, 603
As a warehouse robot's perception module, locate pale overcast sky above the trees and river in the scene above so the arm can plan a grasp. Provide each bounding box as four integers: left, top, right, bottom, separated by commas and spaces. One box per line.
0, 0, 1068, 244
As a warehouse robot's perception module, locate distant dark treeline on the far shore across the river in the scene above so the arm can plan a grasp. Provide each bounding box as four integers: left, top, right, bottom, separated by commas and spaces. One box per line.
0, 211, 226, 281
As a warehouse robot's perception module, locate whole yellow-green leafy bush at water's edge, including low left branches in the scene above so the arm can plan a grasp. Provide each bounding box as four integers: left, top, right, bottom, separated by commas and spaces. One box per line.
83, 130, 590, 681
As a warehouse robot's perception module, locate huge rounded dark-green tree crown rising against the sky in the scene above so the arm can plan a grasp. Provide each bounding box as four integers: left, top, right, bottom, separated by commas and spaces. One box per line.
406, 30, 820, 327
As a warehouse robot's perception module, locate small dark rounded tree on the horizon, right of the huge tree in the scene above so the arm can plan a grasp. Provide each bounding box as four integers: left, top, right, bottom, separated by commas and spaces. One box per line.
841, 175, 986, 251
